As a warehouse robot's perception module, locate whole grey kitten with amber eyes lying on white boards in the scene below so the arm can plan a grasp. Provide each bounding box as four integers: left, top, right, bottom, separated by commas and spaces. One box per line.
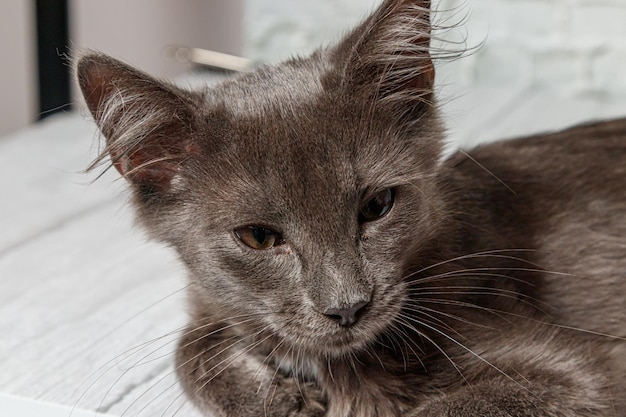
78, 0, 626, 417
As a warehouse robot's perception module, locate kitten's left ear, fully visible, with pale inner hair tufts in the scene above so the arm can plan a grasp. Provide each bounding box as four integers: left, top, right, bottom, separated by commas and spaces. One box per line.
77, 53, 197, 193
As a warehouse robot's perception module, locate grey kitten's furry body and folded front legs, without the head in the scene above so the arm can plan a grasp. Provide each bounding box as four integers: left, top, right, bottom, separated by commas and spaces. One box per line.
179, 119, 626, 416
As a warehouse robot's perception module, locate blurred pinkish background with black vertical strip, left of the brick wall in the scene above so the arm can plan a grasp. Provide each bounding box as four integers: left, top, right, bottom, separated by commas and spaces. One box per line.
0, 0, 243, 135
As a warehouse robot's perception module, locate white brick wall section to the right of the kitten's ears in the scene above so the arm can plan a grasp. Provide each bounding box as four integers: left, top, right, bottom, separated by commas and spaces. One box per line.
456, 0, 626, 95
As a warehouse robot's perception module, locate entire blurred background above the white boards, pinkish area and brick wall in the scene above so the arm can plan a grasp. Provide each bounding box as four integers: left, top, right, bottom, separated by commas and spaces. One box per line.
0, 0, 626, 134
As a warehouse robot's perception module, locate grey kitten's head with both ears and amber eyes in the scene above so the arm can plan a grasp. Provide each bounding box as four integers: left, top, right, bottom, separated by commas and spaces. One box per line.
78, 0, 442, 354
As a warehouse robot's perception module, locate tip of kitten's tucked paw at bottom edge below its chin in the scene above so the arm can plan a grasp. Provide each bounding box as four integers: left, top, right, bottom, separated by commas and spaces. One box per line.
265, 380, 326, 417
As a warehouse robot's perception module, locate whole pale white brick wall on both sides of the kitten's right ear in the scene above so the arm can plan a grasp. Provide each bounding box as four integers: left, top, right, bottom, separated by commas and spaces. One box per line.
244, 0, 626, 95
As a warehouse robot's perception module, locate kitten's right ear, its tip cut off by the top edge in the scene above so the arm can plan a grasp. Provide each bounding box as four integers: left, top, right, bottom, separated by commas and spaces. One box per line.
334, 0, 435, 112
